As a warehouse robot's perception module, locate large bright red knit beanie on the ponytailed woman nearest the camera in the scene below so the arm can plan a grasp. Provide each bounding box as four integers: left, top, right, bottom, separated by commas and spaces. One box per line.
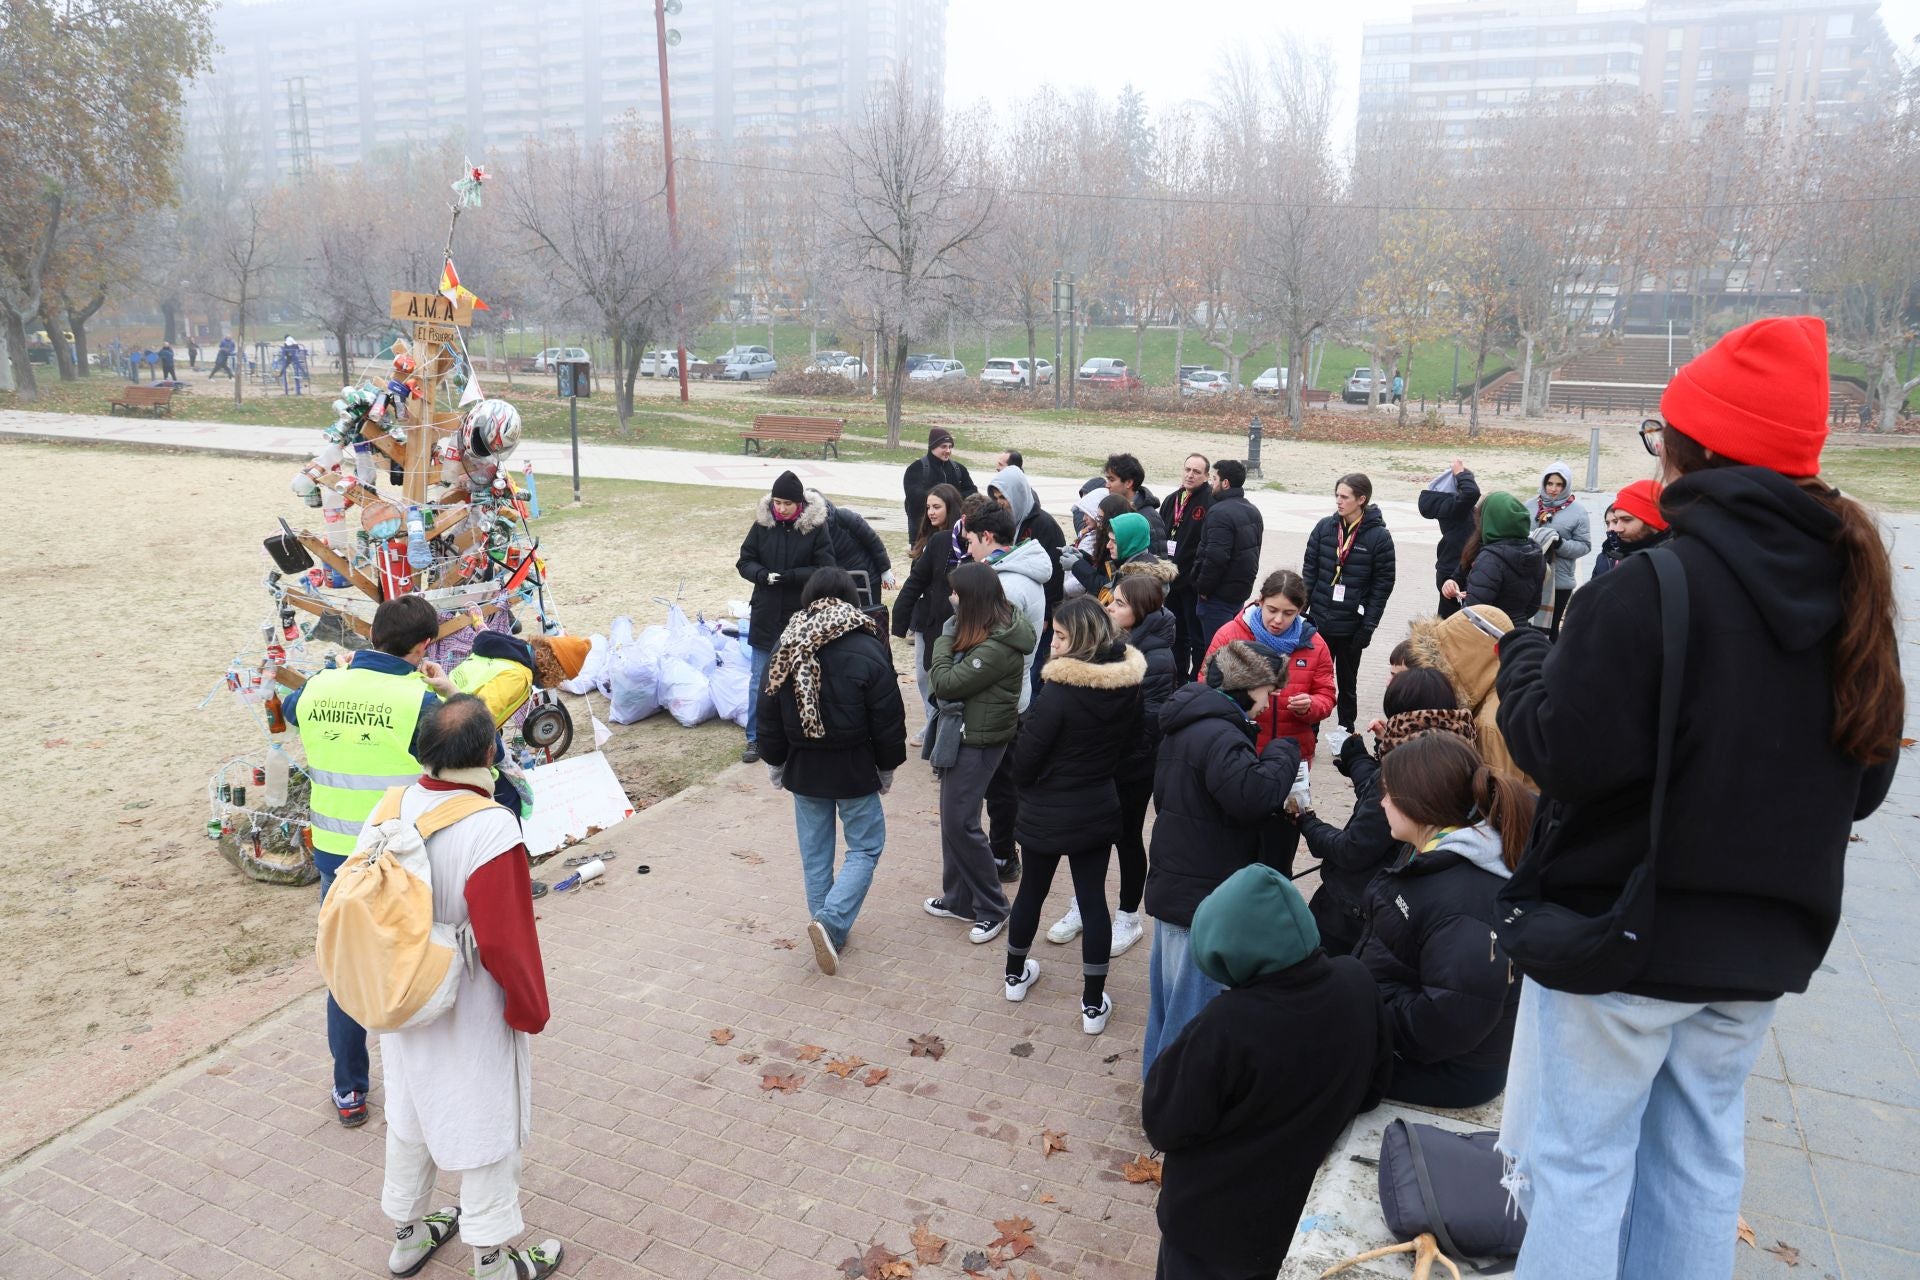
1661, 315, 1828, 476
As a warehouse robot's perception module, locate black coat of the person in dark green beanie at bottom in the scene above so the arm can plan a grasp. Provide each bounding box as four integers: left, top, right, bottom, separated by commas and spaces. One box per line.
1140, 950, 1394, 1276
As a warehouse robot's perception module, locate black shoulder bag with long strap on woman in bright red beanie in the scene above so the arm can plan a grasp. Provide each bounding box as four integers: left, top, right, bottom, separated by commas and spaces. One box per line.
1494, 547, 1688, 996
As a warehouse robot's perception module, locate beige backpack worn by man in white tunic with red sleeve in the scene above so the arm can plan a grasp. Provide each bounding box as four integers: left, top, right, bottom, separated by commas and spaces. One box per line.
315, 787, 493, 1031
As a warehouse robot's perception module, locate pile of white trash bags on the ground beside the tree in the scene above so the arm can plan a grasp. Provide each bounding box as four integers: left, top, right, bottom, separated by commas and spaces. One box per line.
561, 604, 753, 727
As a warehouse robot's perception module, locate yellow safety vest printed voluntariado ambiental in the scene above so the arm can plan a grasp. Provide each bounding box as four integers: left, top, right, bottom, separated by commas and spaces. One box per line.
296, 666, 424, 858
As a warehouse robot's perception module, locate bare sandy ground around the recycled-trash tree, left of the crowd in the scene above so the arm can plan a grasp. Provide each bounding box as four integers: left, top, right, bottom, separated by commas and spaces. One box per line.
0, 443, 883, 1105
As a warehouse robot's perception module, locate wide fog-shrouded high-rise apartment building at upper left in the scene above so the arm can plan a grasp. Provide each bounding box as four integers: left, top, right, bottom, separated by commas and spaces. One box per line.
188, 0, 947, 175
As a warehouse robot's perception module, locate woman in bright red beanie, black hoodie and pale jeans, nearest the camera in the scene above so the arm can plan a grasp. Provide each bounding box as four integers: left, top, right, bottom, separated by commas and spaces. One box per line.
1500, 317, 1907, 1280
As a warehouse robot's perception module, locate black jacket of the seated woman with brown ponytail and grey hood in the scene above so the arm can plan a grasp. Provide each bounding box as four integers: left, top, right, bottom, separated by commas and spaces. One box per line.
1354, 825, 1521, 1069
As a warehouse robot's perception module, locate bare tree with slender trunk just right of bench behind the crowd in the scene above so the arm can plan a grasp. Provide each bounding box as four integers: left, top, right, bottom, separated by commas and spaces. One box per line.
829, 77, 993, 449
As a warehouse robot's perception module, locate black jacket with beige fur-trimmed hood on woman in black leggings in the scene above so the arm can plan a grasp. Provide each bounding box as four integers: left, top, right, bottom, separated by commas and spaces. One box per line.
1014, 645, 1146, 854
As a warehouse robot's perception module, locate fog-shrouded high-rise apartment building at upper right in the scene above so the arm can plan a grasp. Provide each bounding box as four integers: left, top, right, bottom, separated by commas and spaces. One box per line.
1359, 0, 1897, 146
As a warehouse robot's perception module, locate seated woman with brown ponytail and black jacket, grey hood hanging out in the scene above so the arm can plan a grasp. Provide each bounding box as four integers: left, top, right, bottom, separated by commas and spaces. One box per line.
1354, 731, 1534, 1107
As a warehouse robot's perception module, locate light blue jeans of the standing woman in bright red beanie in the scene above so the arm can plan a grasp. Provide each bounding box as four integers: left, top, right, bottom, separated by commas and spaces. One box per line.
1500, 981, 1774, 1280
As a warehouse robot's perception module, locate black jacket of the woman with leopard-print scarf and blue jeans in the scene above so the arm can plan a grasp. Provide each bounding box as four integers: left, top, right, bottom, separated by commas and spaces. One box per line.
758, 631, 906, 800
